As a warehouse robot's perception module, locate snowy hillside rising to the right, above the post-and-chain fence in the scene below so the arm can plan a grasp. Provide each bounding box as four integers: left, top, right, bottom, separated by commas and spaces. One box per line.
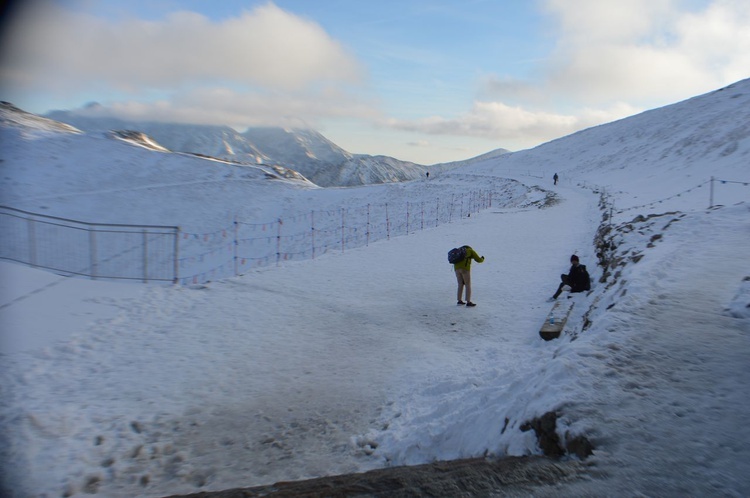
488, 79, 750, 210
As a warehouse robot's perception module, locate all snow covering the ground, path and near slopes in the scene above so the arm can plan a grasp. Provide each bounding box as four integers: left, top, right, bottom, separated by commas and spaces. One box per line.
0, 81, 750, 497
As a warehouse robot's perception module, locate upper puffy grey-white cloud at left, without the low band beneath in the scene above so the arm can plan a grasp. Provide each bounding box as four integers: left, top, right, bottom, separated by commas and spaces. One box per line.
0, 2, 364, 94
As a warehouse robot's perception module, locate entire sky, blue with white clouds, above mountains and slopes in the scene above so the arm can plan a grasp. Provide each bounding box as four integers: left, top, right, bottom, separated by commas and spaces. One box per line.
0, 0, 750, 164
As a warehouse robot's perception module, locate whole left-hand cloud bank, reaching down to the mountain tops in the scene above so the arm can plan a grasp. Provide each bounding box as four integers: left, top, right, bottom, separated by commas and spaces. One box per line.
0, 1, 374, 129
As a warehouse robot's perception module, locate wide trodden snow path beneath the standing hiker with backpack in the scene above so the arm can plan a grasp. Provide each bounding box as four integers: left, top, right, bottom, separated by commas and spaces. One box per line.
0, 176, 598, 496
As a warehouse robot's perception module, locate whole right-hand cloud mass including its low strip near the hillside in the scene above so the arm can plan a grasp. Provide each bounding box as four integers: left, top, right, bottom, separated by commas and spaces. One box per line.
464, 0, 750, 145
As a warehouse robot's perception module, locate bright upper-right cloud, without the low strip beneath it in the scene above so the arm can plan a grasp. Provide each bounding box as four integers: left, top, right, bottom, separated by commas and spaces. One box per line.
543, 0, 750, 105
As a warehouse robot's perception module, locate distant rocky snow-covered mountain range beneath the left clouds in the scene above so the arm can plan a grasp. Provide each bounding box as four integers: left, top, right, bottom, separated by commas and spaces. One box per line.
45, 109, 470, 187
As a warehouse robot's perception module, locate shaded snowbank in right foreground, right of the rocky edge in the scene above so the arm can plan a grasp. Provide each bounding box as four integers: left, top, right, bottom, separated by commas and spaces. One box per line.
532, 207, 750, 496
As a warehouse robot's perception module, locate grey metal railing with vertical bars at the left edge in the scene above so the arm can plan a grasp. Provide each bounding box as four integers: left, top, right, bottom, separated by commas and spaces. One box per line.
0, 206, 180, 282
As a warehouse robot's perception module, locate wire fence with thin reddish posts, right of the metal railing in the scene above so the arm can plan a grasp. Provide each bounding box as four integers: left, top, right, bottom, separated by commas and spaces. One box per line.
179, 190, 497, 284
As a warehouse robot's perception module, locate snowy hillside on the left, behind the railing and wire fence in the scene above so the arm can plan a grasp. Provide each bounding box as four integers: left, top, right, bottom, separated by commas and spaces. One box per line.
0, 104, 545, 282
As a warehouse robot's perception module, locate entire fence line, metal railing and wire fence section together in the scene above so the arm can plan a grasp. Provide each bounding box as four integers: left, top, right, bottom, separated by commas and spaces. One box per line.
0, 190, 497, 284
